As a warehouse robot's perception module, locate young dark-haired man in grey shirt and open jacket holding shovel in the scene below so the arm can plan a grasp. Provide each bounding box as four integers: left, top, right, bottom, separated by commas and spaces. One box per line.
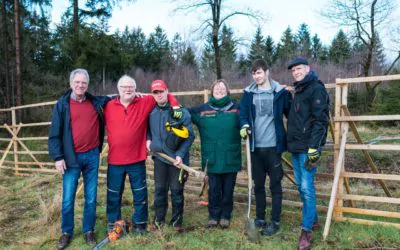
240, 59, 291, 235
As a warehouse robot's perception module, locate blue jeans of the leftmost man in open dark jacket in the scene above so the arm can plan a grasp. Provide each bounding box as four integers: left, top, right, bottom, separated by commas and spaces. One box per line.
61, 147, 99, 236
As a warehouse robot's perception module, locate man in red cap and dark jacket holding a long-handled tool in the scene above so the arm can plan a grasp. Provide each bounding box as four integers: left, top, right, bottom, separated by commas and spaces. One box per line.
147, 80, 194, 232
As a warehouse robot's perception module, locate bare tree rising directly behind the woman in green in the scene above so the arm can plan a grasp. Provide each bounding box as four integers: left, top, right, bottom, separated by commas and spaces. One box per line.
172, 0, 264, 79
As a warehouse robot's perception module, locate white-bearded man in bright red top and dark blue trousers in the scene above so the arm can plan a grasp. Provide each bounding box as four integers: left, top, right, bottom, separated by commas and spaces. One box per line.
104, 75, 182, 234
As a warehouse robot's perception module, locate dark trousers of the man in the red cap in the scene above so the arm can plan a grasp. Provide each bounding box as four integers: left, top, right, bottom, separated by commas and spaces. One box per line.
154, 158, 184, 227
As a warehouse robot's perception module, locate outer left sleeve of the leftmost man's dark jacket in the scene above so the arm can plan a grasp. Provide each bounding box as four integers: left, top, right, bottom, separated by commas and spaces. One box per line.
48, 102, 64, 161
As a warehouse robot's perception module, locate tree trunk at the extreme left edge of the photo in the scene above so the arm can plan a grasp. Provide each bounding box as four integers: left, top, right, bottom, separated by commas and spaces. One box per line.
1, 0, 10, 107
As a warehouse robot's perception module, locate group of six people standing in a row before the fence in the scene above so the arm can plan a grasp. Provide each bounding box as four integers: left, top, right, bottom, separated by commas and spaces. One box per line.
48, 58, 329, 249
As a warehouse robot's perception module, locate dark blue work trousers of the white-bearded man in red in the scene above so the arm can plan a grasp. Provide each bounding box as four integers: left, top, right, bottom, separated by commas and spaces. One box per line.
107, 161, 148, 225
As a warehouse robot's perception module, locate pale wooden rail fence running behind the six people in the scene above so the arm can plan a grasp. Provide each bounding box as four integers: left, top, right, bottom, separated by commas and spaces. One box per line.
0, 75, 400, 239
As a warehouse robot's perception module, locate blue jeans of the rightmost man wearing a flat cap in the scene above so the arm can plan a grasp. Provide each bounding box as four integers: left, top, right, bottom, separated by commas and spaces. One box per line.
292, 153, 318, 232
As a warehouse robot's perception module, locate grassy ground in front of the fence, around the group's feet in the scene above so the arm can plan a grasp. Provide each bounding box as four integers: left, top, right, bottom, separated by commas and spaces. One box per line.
0, 172, 400, 250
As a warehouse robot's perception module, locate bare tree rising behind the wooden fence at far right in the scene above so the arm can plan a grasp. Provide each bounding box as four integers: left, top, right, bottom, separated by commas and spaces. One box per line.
322, 0, 400, 105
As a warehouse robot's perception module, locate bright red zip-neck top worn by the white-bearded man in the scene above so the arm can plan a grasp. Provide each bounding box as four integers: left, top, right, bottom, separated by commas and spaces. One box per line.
104, 94, 179, 165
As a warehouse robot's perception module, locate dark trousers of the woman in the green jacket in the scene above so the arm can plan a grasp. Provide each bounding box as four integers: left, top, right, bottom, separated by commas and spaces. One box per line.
208, 172, 237, 221
